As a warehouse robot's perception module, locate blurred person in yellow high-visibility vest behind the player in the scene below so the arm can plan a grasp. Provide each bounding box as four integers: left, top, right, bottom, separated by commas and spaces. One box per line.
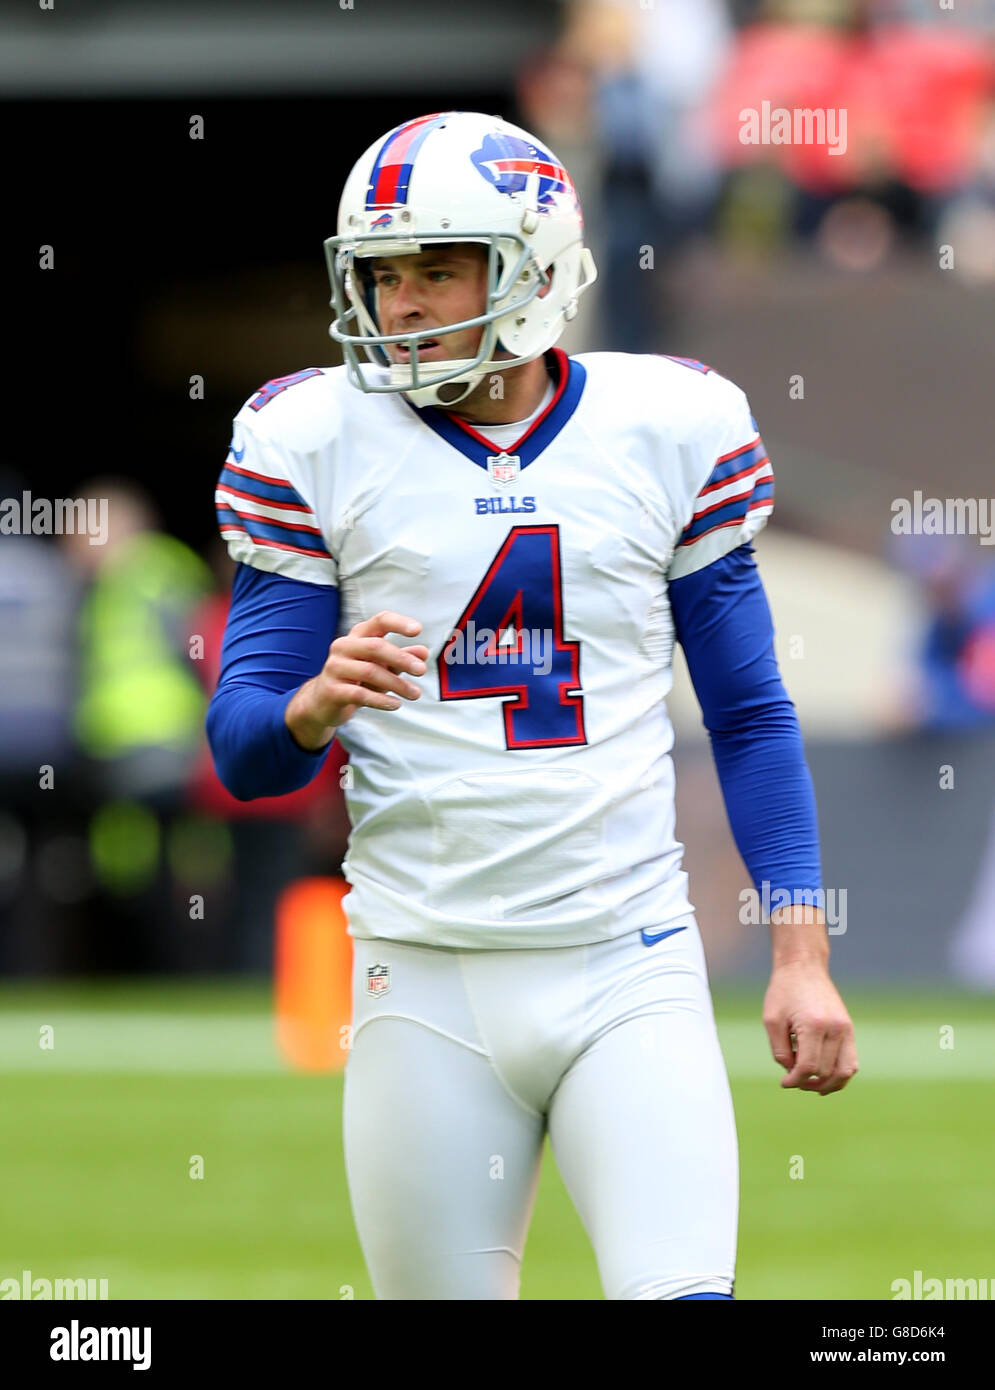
63, 478, 211, 970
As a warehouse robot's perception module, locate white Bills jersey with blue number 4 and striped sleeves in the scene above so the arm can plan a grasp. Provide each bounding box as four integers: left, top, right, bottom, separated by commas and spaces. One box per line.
217, 349, 774, 948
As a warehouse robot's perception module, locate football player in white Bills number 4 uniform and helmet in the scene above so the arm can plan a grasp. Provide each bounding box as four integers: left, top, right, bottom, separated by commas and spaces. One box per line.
208, 111, 856, 1300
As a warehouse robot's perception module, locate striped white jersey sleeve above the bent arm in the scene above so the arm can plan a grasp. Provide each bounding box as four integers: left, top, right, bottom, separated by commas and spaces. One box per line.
214, 378, 338, 585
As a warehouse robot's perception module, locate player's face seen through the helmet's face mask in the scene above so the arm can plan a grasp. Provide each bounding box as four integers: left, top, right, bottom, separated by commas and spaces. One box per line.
372, 245, 488, 363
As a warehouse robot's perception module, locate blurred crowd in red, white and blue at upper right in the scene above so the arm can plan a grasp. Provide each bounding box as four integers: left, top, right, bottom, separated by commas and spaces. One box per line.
518, 0, 995, 352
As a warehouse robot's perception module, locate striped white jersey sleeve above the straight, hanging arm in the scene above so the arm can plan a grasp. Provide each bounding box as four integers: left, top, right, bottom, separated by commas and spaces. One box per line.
667, 363, 774, 580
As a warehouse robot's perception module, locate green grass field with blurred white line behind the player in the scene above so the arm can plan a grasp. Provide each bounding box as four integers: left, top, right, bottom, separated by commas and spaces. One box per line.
0, 981, 995, 1300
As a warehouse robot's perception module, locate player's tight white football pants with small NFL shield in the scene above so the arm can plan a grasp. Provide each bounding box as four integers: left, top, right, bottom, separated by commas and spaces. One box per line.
345, 917, 739, 1300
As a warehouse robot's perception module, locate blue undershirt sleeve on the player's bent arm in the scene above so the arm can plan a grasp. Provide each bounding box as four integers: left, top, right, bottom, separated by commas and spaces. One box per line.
207, 564, 339, 801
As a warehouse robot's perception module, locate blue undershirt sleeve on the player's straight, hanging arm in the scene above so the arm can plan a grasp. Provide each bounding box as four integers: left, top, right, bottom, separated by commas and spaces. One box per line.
670, 543, 821, 906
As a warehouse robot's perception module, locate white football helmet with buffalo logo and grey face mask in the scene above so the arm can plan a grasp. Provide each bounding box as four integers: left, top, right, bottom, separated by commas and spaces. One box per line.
325, 111, 598, 407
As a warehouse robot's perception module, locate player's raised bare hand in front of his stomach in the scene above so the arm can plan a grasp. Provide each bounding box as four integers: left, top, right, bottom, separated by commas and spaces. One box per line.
283, 612, 428, 751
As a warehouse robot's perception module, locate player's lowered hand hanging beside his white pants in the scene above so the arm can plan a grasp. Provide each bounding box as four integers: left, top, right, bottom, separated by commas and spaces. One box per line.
763, 959, 857, 1095
